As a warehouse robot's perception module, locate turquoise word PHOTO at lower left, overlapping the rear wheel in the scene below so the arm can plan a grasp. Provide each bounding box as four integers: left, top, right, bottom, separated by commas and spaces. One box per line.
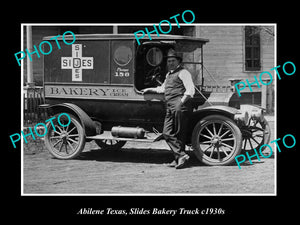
9, 113, 71, 148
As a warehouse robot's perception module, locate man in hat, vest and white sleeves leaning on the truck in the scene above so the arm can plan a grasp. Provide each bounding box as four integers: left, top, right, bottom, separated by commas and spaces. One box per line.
142, 49, 195, 169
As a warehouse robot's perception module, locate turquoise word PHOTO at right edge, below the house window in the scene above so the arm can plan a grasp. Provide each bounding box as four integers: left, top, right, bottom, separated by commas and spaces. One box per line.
234, 61, 296, 96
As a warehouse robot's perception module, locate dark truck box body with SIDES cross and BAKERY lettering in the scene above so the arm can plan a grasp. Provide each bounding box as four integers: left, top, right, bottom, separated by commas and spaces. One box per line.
44, 35, 165, 129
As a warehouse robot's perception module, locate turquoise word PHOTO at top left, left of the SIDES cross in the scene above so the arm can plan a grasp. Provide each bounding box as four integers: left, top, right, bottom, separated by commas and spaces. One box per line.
15, 31, 76, 66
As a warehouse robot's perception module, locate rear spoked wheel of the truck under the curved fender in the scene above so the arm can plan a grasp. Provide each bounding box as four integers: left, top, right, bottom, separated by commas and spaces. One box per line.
45, 114, 85, 159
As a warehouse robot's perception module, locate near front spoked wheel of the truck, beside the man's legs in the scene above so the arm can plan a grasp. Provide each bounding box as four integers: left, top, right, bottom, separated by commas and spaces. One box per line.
192, 115, 242, 166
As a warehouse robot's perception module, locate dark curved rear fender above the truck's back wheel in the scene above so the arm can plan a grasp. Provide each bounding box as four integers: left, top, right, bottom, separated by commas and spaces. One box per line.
39, 103, 96, 136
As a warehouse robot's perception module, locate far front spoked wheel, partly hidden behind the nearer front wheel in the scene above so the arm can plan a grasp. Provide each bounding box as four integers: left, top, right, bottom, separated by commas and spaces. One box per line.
241, 118, 271, 151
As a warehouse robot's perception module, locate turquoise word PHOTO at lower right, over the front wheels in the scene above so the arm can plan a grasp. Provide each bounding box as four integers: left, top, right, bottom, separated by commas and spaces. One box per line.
235, 134, 296, 169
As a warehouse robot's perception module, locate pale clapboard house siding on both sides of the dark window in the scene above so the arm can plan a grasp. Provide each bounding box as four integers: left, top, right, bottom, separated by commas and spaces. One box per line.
195, 26, 275, 91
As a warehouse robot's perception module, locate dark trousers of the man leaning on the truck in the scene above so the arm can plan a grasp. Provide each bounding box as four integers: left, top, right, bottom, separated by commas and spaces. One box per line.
163, 97, 191, 162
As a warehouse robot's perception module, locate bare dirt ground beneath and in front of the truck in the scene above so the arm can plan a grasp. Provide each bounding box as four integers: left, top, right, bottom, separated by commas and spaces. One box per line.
23, 116, 276, 195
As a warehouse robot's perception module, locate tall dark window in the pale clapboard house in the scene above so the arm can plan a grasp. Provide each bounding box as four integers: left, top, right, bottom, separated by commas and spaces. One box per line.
245, 26, 261, 71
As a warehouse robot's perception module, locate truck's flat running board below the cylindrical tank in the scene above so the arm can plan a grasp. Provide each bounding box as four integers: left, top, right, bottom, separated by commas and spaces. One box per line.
86, 131, 163, 142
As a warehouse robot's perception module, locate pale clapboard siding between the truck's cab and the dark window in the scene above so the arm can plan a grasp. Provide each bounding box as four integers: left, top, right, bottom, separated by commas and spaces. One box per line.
196, 26, 243, 85
